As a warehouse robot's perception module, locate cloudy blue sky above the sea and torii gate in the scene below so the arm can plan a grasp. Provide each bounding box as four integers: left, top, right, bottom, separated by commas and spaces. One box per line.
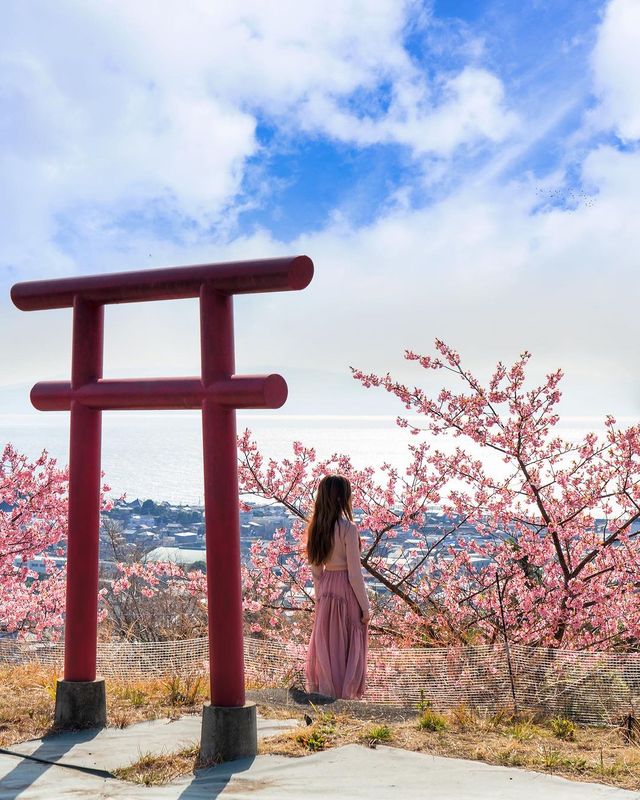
0, 0, 640, 415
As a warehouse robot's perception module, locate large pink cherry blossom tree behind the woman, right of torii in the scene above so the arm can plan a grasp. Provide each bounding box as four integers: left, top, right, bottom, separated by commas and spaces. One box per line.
239, 340, 640, 648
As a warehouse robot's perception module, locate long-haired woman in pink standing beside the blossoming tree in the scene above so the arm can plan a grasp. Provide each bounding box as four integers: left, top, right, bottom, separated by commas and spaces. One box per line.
305, 475, 370, 699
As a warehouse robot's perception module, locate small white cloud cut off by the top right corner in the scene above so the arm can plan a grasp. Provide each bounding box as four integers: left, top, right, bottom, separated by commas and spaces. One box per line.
593, 0, 640, 140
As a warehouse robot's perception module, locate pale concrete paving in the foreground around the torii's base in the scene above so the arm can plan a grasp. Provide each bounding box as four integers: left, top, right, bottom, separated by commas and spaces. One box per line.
0, 717, 640, 800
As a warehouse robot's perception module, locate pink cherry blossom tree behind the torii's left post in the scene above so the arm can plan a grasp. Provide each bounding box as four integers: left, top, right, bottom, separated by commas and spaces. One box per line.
0, 444, 206, 641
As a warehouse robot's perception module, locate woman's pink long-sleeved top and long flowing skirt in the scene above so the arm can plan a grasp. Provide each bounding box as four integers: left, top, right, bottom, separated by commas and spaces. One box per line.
305, 519, 369, 699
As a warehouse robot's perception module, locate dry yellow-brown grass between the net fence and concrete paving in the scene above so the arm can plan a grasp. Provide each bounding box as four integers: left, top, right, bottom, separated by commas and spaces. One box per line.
0, 664, 640, 791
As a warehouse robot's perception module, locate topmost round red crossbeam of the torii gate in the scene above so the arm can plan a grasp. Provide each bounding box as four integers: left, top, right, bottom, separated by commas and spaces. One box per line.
11, 256, 313, 311
